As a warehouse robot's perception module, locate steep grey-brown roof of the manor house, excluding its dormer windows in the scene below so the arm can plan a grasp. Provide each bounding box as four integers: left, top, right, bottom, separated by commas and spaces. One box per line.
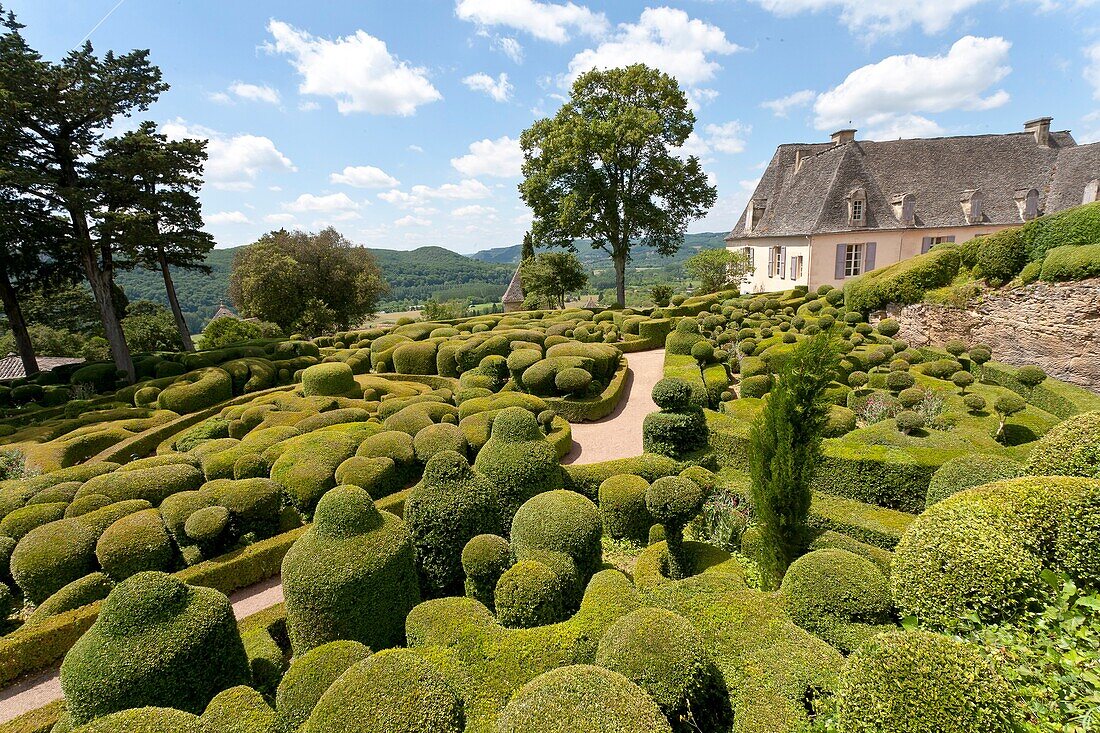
726, 131, 1100, 240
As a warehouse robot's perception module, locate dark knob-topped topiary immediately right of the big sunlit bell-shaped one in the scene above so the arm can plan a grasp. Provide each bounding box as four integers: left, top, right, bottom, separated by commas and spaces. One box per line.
405, 449, 501, 595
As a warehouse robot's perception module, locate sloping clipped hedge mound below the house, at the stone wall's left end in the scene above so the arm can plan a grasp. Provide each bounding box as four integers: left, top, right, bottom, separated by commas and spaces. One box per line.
840, 247, 959, 313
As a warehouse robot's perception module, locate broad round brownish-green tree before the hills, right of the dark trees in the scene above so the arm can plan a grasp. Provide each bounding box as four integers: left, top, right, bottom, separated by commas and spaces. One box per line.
229, 227, 388, 335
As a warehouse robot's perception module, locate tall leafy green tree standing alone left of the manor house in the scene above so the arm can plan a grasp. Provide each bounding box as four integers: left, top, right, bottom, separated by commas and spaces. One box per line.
519, 64, 717, 307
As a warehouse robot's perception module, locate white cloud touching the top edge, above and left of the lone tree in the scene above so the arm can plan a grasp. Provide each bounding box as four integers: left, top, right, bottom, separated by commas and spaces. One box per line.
454, 0, 607, 43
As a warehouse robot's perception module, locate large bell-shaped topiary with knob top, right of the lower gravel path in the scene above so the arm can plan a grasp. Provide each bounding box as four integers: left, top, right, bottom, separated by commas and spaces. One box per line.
283, 486, 420, 654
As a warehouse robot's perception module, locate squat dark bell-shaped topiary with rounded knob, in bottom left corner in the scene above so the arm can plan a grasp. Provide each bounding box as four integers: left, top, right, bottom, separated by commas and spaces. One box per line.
61, 572, 249, 725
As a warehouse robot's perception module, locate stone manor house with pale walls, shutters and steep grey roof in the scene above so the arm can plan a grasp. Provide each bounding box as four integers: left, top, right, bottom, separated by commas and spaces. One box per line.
726, 117, 1100, 293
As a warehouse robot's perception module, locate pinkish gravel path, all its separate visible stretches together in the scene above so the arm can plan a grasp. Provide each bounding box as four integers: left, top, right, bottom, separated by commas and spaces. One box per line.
0, 349, 664, 724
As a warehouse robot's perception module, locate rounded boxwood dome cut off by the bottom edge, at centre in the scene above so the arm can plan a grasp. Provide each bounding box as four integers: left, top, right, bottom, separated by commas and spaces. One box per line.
496, 665, 672, 733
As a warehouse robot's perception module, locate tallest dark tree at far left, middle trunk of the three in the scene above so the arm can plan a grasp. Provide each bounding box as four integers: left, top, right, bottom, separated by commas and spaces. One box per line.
0, 8, 168, 382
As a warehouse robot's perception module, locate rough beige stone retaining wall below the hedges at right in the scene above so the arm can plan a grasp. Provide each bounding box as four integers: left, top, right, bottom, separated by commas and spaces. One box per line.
887, 278, 1100, 392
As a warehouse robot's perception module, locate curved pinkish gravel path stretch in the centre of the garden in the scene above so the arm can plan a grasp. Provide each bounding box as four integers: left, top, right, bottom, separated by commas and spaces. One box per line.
562, 349, 664, 463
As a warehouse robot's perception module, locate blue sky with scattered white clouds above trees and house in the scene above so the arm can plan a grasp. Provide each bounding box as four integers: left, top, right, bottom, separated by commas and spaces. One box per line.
3, 0, 1100, 253
